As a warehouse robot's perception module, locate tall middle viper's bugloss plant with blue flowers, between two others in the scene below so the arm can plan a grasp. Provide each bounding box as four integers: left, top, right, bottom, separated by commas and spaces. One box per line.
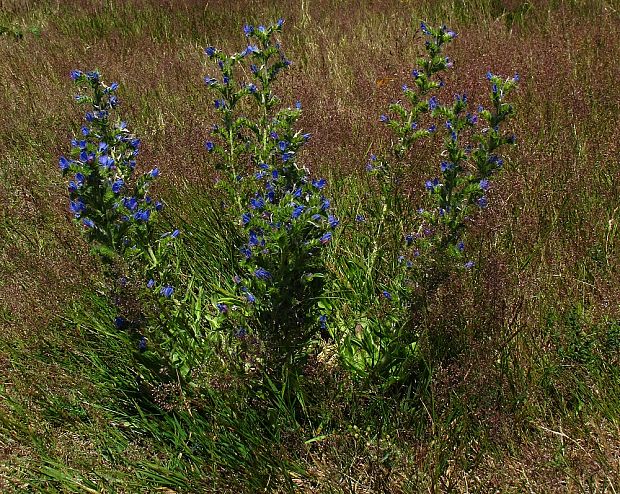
205, 20, 339, 372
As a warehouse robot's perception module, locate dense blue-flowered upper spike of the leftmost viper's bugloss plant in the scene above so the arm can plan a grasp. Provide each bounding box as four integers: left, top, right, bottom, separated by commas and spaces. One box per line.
59, 70, 162, 258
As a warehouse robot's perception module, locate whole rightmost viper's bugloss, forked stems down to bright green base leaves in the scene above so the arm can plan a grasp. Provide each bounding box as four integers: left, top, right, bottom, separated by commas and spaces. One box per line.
341, 23, 518, 384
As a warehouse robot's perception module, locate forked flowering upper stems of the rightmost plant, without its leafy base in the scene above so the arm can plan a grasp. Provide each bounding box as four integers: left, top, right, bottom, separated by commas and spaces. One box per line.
369, 22, 519, 274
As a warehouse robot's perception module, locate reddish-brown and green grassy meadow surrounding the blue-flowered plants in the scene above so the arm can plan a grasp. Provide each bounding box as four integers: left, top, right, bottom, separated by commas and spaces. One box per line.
0, 0, 620, 494
